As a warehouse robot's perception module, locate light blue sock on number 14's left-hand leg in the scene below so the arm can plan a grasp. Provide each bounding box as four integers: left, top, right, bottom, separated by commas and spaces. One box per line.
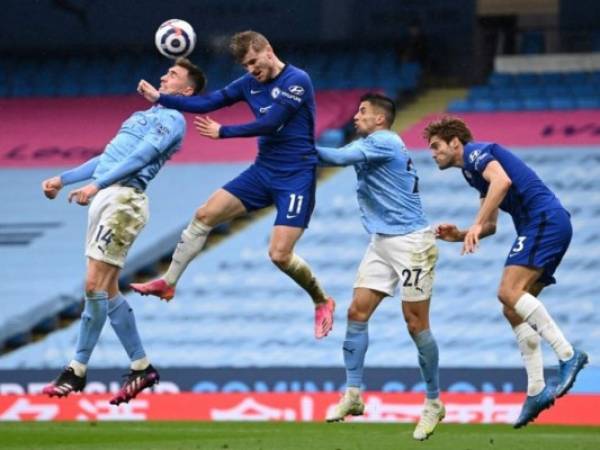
74, 291, 108, 364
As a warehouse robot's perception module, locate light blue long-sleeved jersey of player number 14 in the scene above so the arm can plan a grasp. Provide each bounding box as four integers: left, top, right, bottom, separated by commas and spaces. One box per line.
93, 106, 185, 190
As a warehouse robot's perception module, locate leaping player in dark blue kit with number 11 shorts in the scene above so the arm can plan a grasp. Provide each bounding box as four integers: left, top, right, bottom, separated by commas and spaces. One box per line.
131, 31, 335, 339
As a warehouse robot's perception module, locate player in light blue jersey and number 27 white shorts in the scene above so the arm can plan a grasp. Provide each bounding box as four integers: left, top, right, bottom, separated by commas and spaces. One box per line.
317, 93, 445, 440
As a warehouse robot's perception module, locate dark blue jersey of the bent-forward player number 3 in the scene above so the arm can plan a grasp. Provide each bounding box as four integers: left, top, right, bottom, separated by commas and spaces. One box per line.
462, 142, 564, 230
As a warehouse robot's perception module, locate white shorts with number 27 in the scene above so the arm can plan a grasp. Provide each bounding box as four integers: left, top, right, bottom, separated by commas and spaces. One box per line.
354, 228, 438, 302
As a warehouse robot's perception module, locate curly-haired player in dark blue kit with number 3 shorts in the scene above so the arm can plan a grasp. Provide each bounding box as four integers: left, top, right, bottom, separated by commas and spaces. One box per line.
423, 117, 588, 428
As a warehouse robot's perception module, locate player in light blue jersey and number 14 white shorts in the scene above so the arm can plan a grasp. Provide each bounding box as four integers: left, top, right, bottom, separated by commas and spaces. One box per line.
42, 59, 206, 405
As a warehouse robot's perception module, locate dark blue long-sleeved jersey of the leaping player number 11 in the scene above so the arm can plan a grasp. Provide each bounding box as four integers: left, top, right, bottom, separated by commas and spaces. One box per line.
158, 64, 318, 172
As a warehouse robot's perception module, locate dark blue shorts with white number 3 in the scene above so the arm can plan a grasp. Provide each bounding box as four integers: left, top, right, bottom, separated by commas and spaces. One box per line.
504, 209, 573, 286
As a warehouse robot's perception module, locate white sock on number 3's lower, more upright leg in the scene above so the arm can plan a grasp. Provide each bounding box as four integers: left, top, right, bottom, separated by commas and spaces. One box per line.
513, 322, 546, 396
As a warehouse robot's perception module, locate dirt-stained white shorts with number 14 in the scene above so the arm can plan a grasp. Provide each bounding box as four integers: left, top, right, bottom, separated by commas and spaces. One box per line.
85, 185, 149, 268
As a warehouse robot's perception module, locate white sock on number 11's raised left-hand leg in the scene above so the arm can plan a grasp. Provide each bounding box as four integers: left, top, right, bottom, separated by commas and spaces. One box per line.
163, 218, 212, 286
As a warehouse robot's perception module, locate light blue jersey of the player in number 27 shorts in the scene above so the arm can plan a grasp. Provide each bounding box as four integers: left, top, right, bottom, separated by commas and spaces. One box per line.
317, 130, 428, 235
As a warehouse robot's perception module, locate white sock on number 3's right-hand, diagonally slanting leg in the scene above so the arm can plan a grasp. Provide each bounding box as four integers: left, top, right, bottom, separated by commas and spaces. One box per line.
515, 292, 573, 361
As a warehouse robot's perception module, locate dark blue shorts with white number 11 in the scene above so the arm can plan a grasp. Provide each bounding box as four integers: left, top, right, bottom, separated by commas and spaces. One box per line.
223, 164, 317, 228
